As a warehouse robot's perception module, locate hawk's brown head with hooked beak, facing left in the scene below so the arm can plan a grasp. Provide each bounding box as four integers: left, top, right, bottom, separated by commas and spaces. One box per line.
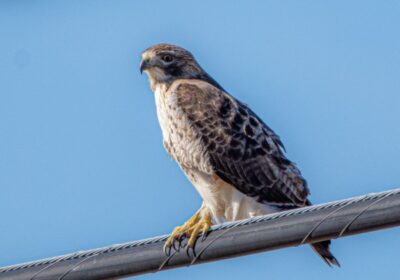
140, 44, 222, 90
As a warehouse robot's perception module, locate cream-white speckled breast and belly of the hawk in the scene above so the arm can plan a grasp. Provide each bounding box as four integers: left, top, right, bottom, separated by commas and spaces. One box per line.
154, 87, 276, 223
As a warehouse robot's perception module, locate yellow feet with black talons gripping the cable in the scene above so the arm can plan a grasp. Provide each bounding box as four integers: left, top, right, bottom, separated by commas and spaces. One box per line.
164, 209, 211, 256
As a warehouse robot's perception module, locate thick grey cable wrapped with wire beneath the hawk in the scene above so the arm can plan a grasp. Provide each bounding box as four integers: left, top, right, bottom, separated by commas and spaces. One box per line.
0, 189, 400, 280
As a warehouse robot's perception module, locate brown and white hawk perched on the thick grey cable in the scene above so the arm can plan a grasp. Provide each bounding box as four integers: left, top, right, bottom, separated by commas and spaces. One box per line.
140, 44, 339, 266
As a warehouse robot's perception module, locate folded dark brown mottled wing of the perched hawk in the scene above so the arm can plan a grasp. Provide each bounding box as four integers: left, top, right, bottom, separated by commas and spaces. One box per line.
173, 80, 309, 208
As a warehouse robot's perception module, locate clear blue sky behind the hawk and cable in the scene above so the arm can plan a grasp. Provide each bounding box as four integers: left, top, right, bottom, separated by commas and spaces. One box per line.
0, 0, 400, 280
